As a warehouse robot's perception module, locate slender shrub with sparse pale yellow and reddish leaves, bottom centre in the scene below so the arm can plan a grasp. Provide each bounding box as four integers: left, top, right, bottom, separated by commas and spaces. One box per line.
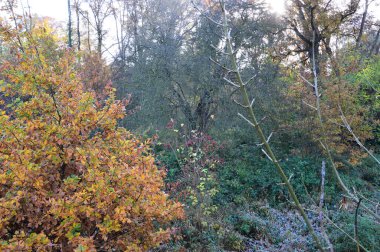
155, 127, 225, 251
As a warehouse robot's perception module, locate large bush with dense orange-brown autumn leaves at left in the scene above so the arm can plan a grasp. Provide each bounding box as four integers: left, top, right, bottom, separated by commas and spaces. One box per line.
0, 20, 183, 251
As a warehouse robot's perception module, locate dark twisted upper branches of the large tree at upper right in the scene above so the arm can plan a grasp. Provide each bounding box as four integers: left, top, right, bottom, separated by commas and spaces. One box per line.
286, 0, 359, 75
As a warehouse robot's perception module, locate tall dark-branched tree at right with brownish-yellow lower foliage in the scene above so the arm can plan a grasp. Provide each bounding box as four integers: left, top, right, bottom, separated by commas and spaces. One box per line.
280, 0, 376, 160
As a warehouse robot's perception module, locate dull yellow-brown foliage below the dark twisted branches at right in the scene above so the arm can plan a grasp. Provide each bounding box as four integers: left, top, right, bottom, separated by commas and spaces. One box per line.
285, 68, 377, 164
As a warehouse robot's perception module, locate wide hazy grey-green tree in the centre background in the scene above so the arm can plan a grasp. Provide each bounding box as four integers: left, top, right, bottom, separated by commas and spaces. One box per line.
112, 0, 278, 132
